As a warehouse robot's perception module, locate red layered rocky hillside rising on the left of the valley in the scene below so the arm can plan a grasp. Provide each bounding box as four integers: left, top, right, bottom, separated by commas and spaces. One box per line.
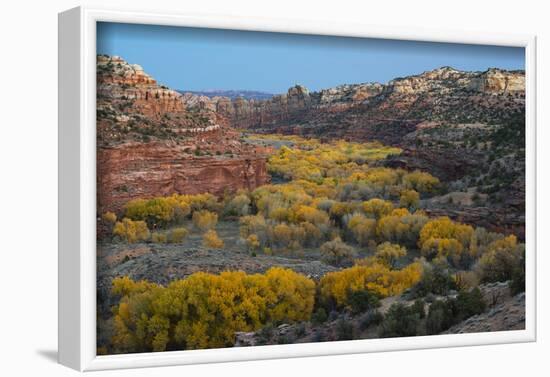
97, 55, 269, 213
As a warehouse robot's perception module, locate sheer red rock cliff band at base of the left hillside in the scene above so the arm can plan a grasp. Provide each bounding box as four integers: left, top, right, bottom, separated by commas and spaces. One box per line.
97, 142, 269, 213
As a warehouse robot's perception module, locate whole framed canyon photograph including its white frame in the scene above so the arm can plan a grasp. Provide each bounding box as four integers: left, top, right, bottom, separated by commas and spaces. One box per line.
59, 7, 536, 370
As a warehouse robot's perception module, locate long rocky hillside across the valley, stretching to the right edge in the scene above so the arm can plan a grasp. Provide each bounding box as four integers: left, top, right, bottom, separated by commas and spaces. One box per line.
183, 67, 525, 237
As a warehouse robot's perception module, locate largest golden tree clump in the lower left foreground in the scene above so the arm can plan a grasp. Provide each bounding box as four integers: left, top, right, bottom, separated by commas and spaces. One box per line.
111, 268, 315, 352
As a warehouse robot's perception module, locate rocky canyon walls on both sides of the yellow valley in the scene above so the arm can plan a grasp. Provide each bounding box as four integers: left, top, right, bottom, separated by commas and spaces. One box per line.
97, 56, 525, 238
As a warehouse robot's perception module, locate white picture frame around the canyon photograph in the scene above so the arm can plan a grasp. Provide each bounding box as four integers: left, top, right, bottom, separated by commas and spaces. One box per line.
58, 7, 536, 371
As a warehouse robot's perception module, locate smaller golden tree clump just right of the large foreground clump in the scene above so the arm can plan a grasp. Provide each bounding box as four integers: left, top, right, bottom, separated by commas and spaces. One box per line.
319, 260, 422, 307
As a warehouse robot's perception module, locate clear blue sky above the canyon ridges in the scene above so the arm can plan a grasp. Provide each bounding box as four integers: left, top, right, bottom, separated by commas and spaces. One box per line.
97, 23, 525, 93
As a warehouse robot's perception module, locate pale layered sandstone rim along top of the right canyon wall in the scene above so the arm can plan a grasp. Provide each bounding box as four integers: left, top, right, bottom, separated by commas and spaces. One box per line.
183, 67, 525, 134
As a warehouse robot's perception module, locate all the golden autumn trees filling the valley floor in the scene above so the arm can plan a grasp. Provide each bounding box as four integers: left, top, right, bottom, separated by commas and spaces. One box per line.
102, 135, 525, 352
